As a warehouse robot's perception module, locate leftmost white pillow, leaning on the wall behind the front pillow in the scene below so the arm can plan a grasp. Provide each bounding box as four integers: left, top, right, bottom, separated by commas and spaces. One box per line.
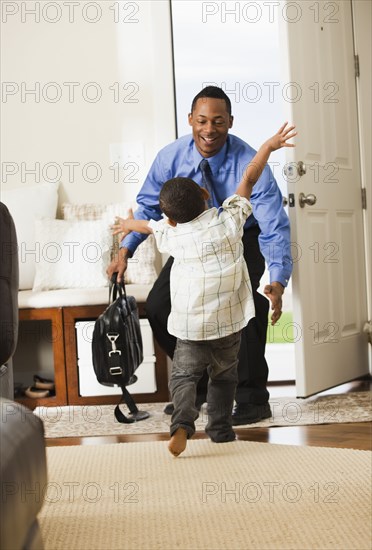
1, 183, 59, 290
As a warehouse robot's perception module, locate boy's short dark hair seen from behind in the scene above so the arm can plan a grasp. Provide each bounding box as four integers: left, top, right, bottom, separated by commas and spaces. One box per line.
159, 177, 205, 223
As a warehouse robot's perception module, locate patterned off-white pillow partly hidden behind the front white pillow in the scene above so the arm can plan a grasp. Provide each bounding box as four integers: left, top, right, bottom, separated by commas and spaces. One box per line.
62, 202, 157, 285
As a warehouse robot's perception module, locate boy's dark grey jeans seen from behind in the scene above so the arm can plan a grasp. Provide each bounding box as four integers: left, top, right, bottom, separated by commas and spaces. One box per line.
169, 332, 241, 443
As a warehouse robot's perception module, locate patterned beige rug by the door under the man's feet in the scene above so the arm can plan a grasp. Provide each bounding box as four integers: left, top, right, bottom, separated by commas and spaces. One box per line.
35, 391, 372, 437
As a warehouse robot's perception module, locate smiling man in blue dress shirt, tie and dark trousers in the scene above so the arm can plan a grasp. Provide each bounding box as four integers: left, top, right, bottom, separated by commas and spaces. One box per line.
107, 86, 292, 426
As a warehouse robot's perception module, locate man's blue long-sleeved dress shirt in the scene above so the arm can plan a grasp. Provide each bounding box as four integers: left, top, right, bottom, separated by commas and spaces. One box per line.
121, 134, 292, 286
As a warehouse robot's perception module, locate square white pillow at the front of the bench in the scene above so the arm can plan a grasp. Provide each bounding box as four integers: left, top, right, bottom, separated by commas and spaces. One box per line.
33, 219, 112, 290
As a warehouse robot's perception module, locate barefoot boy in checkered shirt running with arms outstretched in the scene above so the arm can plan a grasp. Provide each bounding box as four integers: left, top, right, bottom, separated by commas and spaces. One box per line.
113, 123, 296, 456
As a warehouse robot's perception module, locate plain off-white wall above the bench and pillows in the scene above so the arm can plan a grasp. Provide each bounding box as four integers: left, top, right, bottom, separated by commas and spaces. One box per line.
1, 0, 175, 211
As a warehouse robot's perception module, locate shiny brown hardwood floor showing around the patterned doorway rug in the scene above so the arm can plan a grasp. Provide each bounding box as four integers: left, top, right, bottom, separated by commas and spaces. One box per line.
46, 378, 372, 451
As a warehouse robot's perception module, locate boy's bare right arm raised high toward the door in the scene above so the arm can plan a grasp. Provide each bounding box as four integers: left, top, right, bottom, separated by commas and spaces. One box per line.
236, 122, 297, 199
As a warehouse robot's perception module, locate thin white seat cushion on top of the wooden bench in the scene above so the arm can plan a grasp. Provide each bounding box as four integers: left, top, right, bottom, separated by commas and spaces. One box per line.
18, 284, 152, 309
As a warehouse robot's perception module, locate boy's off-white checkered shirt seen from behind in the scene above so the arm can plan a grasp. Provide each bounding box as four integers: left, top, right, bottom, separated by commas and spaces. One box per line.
149, 195, 255, 340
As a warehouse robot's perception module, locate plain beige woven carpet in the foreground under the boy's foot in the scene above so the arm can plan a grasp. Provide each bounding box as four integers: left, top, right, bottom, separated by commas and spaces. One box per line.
39, 440, 372, 550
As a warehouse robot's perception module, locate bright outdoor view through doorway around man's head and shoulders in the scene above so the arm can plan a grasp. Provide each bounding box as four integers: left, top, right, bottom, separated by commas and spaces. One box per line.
171, 0, 287, 195
